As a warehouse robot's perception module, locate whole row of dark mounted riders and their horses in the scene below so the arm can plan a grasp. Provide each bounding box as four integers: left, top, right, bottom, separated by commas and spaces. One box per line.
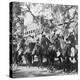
12, 29, 78, 72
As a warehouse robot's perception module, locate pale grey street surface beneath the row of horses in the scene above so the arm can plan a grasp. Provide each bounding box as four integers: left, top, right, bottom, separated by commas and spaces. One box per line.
13, 66, 76, 78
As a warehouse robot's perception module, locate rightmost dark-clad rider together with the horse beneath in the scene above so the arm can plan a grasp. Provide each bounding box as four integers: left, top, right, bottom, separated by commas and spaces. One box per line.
64, 32, 75, 71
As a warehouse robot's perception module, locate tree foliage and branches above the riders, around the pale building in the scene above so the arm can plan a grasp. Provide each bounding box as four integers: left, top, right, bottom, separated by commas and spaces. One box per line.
13, 2, 78, 42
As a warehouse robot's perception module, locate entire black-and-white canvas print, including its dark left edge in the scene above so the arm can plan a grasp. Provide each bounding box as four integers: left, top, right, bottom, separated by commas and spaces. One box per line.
9, 2, 78, 78
